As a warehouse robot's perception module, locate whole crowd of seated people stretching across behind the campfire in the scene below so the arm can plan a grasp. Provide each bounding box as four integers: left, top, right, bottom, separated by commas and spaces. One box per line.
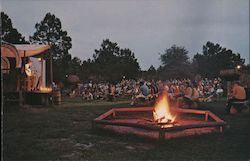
64, 78, 223, 106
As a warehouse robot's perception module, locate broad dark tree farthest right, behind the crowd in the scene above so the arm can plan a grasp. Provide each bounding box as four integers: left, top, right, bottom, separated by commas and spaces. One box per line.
193, 41, 245, 77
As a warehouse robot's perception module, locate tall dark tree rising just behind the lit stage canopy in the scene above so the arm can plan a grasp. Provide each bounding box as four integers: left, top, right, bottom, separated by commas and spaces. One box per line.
30, 13, 72, 81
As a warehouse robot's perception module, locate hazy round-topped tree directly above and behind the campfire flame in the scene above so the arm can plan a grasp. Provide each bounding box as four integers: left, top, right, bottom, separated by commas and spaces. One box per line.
158, 45, 192, 79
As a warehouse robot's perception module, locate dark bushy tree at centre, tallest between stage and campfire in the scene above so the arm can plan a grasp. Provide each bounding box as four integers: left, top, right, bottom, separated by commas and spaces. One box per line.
93, 39, 140, 81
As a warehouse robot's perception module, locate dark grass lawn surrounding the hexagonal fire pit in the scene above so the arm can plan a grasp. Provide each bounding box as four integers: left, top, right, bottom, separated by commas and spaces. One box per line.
2, 98, 250, 161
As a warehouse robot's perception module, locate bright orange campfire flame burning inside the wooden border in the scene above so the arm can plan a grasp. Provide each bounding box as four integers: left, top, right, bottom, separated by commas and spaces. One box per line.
153, 92, 176, 123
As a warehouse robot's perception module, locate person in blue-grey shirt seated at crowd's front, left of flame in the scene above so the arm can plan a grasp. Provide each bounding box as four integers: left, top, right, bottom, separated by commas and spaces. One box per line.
131, 81, 150, 105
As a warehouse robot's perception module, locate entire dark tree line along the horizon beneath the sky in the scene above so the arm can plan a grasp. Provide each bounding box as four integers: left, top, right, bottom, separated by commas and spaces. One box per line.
1, 12, 250, 82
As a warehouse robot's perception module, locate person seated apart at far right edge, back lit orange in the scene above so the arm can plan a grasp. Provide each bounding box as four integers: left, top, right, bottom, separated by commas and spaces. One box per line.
226, 82, 246, 113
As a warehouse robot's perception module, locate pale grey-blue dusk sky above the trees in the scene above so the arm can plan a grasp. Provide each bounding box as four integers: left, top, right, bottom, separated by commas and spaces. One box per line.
1, 0, 250, 70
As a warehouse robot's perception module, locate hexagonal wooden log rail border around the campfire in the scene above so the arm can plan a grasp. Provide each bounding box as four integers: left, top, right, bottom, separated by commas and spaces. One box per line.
92, 107, 226, 139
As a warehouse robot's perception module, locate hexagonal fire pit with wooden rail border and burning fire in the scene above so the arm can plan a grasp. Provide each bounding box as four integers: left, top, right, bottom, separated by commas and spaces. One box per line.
92, 92, 226, 140
